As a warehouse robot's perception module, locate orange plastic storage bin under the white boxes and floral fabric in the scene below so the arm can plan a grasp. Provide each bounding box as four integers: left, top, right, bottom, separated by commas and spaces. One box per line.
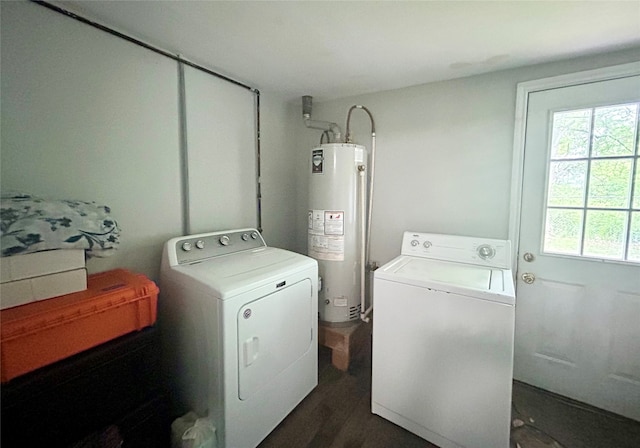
0, 269, 158, 383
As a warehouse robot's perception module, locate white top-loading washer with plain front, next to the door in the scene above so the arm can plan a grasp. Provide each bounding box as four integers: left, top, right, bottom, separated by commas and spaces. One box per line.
371, 232, 515, 448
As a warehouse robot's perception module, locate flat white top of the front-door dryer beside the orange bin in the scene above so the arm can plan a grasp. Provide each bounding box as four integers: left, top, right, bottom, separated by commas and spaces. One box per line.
165, 247, 316, 299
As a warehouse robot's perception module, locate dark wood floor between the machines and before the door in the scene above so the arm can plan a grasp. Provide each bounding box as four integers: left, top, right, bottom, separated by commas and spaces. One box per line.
258, 341, 640, 448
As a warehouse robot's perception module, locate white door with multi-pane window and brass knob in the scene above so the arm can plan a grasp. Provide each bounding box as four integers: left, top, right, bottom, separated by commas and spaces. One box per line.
514, 71, 640, 420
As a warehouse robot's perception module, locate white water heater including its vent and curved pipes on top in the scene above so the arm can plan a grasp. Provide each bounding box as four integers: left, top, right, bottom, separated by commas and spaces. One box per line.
302, 95, 376, 326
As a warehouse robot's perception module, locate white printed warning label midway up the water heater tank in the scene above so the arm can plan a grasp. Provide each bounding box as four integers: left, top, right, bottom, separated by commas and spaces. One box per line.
308, 210, 344, 261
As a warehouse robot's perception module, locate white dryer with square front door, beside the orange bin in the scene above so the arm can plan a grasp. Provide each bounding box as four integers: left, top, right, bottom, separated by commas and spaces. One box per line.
158, 229, 318, 448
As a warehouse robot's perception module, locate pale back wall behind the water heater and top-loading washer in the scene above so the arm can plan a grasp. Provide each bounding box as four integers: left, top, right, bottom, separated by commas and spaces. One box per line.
290, 48, 640, 263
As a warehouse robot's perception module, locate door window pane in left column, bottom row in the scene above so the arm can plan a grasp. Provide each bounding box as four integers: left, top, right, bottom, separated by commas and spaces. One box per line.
544, 209, 582, 255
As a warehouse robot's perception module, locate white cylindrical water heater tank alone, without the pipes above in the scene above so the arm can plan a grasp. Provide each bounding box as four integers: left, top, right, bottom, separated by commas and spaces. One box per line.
308, 143, 367, 326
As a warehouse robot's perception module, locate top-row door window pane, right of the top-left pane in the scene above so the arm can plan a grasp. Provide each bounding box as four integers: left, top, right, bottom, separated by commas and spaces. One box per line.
592, 104, 638, 157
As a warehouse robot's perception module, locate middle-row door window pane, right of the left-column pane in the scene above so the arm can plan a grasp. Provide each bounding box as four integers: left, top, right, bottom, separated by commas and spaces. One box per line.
588, 159, 632, 208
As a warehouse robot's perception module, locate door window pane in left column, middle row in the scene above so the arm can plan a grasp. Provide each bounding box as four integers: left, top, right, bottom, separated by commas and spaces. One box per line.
547, 161, 587, 207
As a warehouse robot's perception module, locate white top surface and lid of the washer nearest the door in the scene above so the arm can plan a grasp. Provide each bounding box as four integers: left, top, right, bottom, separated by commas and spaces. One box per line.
374, 255, 515, 304
